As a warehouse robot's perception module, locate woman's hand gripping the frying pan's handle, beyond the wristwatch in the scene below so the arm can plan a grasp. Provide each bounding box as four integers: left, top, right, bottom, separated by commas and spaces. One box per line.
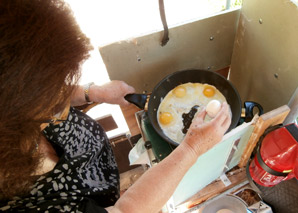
89, 80, 135, 106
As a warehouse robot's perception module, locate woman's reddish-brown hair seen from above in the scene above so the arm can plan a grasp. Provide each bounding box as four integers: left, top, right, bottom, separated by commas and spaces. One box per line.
0, 0, 92, 199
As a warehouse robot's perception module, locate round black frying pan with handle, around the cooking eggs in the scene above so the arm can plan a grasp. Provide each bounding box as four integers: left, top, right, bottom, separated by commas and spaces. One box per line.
125, 70, 262, 146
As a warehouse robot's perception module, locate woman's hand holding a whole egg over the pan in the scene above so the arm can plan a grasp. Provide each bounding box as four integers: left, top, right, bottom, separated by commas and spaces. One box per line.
182, 102, 231, 157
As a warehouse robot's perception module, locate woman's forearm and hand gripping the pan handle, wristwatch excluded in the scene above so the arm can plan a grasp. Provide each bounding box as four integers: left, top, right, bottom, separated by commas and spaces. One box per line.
71, 80, 135, 106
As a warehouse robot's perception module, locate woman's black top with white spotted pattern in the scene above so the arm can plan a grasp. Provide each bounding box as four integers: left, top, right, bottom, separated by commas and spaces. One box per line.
0, 108, 119, 212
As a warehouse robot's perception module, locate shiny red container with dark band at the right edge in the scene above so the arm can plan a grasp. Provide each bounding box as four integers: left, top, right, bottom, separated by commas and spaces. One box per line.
249, 123, 298, 187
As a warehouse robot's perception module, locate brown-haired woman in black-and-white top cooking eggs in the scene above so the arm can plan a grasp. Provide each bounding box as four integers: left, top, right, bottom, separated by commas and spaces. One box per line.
0, 0, 231, 212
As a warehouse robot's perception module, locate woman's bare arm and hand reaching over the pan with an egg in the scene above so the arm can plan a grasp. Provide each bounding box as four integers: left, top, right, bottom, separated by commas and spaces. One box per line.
107, 103, 231, 213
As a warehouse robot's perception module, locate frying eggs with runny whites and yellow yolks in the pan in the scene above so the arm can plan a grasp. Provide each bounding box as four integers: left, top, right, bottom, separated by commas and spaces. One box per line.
157, 83, 226, 143
